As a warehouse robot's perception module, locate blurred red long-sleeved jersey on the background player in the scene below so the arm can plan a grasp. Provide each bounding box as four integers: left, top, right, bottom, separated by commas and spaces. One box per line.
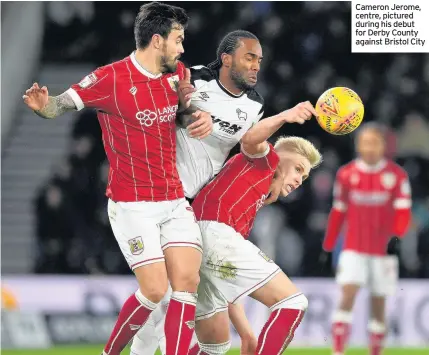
325, 159, 411, 255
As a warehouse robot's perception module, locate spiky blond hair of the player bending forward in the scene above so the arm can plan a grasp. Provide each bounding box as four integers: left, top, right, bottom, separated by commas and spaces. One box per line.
274, 136, 322, 169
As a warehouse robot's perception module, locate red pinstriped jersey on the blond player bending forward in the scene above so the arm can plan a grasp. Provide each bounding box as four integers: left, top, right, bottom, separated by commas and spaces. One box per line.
192, 144, 279, 238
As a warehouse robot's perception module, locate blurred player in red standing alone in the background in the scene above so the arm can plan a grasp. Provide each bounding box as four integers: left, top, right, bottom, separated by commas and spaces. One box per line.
323, 123, 411, 355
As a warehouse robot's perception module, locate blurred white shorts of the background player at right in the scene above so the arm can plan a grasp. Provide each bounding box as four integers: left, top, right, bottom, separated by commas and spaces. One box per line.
336, 250, 398, 296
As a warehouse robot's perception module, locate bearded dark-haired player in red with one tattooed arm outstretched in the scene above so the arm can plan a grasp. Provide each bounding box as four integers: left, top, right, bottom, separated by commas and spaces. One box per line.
23, 2, 212, 355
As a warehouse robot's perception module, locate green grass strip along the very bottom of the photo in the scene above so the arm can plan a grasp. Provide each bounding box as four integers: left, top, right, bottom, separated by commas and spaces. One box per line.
1, 345, 429, 355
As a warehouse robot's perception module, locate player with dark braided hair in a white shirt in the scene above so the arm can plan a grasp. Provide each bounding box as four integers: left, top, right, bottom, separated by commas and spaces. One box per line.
131, 30, 304, 355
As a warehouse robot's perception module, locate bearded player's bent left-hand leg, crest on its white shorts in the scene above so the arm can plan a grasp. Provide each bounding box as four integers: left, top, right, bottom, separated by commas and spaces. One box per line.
104, 201, 168, 355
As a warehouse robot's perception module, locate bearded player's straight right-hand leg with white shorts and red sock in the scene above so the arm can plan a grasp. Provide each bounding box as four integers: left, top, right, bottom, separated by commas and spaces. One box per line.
161, 199, 202, 355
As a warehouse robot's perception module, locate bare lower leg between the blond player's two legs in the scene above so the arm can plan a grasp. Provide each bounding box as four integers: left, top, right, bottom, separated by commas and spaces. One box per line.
228, 303, 258, 355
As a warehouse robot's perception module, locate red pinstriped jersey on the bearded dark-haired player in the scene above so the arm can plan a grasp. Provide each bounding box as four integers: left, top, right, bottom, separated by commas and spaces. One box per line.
67, 53, 185, 202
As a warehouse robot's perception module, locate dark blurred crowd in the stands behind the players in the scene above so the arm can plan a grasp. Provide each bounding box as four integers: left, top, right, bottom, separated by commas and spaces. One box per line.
35, 2, 429, 278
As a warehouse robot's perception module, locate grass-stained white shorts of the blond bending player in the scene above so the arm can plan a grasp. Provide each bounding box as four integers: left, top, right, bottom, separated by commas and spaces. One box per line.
196, 221, 281, 319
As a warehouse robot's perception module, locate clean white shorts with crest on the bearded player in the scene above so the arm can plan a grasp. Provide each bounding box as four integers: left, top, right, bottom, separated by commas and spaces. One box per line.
107, 198, 202, 270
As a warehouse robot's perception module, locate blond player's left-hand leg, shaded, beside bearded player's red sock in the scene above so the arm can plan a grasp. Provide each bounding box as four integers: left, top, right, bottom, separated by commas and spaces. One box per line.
188, 273, 231, 355
